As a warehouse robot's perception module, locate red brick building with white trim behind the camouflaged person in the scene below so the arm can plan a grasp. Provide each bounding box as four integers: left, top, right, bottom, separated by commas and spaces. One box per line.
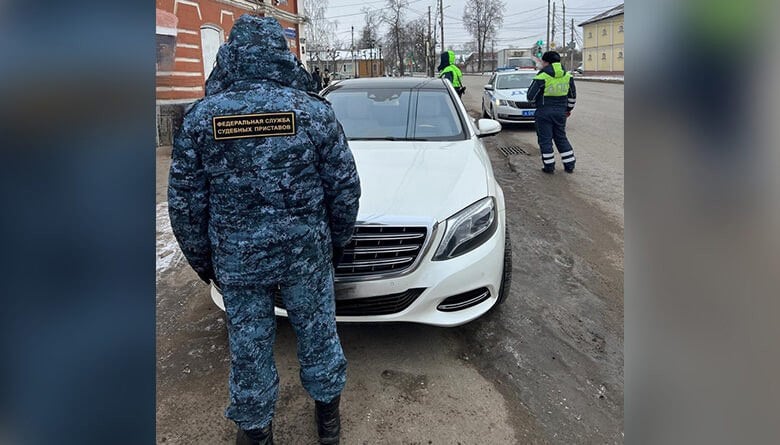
155, 0, 305, 146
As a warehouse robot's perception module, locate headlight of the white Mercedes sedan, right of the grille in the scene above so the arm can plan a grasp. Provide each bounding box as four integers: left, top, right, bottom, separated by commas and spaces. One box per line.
433, 197, 498, 261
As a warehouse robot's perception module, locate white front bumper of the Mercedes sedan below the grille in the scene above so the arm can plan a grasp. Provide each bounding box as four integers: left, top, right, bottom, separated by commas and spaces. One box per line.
211, 213, 506, 326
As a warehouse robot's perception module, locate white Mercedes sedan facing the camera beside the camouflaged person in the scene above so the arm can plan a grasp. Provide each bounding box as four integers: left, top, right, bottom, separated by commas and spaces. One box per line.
211, 78, 512, 326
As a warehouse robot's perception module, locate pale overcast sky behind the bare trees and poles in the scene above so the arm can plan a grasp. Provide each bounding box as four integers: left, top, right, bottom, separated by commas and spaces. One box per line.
327, 0, 623, 49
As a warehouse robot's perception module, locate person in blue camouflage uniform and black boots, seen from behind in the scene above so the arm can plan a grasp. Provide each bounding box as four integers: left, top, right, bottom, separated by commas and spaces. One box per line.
168, 15, 360, 444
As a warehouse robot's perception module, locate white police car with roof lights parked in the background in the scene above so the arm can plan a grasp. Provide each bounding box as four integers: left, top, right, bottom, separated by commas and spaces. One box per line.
482, 69, 537, 123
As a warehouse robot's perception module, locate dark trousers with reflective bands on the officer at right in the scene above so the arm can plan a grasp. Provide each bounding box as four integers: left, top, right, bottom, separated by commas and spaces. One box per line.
535, 106, 575, 170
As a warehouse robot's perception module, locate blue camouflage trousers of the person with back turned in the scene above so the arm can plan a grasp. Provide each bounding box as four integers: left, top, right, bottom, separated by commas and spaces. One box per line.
222, 265, 347, 430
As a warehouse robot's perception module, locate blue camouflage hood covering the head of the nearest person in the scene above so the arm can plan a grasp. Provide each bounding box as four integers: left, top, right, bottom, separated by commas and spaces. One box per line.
206, 14, 317, 96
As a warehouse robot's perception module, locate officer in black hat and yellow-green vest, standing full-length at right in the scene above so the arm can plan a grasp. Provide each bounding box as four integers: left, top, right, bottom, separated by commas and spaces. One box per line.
527, 51, 577, 174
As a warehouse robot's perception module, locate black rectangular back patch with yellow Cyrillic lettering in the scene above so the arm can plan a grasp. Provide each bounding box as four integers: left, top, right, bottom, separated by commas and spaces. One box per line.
212, 111, 297, 141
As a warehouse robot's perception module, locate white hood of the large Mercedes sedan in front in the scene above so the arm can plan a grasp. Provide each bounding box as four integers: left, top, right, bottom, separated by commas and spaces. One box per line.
349, 140, 490, 223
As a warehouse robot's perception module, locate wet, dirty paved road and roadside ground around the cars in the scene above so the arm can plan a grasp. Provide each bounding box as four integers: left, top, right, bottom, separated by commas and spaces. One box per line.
157, 76, 623, 444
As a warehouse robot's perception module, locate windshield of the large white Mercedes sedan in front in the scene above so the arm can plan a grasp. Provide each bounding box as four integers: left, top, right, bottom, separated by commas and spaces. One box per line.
327, 88, 465, 141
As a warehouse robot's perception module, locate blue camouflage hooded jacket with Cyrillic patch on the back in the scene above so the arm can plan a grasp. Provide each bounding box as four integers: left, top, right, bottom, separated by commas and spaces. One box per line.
168, 15, 360, 285
